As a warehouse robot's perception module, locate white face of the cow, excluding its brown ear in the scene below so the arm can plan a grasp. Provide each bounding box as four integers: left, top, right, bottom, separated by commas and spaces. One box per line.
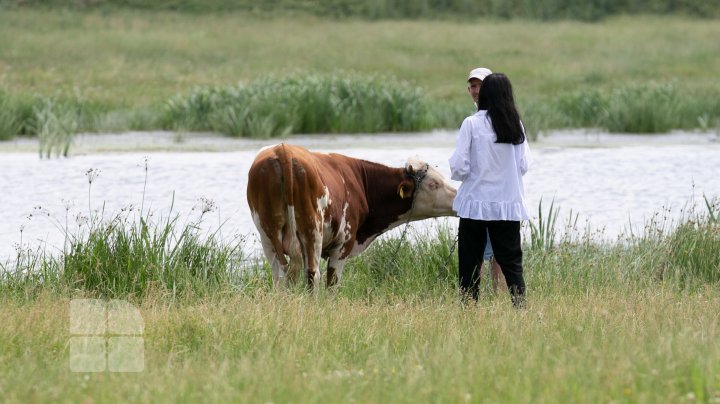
405, 158, 457, 219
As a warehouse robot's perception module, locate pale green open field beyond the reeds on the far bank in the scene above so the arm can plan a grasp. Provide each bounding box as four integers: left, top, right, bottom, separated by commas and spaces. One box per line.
0, 10, 720, 105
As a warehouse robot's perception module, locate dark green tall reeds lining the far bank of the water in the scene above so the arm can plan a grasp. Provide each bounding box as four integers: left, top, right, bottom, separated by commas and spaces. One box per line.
0, 79, 720, 144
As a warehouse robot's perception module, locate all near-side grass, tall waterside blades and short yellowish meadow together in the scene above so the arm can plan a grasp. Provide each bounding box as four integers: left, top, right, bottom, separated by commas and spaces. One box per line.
0, 189, 720, 402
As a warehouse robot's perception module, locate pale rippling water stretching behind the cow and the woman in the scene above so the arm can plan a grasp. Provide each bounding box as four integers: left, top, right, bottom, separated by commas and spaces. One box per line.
0, 132, 720, 260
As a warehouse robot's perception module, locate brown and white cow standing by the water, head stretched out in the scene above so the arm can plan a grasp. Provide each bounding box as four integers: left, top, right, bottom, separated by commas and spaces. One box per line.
247, 143, 456, 287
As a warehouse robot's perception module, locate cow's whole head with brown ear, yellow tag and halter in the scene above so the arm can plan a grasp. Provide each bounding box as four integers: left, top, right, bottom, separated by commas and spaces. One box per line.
398, 157, 457, 220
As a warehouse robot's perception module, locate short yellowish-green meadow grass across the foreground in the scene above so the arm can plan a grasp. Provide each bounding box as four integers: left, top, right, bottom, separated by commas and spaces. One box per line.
0, 288, 720, 402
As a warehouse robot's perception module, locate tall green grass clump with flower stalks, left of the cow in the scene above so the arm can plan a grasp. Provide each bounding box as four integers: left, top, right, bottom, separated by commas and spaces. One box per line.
0, 162, 253, 299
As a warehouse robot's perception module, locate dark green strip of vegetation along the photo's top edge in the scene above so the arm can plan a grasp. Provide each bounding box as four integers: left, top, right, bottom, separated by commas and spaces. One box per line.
0, 0, 720, 21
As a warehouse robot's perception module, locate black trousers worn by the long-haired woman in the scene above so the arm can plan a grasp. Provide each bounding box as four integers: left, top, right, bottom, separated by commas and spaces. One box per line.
458, 218, 525, 305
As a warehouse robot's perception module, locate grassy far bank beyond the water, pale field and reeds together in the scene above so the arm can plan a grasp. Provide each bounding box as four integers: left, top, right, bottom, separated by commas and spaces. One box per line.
0, 8, 720, 144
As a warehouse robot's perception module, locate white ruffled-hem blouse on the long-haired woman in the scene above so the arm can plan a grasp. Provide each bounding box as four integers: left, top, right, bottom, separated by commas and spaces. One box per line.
450, 111, 530, 221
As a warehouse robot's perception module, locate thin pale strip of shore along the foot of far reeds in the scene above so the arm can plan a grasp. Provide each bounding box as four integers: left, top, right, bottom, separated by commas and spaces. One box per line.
0, 129, 720, 157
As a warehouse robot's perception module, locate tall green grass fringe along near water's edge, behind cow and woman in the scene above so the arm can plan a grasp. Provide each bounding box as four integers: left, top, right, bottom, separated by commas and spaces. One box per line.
7, 200, 720, 301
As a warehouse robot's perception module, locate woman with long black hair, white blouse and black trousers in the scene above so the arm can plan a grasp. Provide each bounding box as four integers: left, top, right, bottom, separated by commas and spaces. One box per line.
450, 73, 529, 306
